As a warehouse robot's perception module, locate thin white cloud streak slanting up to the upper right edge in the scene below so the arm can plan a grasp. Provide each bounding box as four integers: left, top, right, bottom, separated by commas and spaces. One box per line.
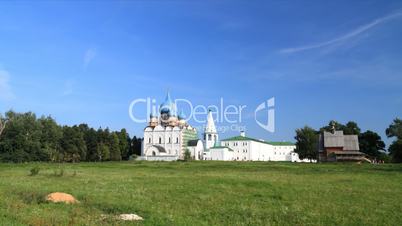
280, 12, 402, 53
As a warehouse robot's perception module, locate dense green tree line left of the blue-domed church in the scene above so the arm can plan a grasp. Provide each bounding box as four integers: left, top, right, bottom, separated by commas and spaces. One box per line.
0, 111, 141, 162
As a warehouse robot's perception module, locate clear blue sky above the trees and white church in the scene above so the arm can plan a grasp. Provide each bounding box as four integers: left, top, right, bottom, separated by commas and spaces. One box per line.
0, 1, 402, 146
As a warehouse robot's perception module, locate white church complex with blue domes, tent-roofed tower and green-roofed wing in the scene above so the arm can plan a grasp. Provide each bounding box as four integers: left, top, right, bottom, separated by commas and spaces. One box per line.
140, 92, 307, 162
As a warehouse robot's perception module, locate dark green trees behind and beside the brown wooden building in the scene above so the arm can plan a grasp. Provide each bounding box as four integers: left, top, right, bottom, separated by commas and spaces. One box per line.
295, 118, 402, 163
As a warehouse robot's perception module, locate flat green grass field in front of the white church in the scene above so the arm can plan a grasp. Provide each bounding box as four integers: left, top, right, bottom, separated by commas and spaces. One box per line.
0, 162, 402, 226
